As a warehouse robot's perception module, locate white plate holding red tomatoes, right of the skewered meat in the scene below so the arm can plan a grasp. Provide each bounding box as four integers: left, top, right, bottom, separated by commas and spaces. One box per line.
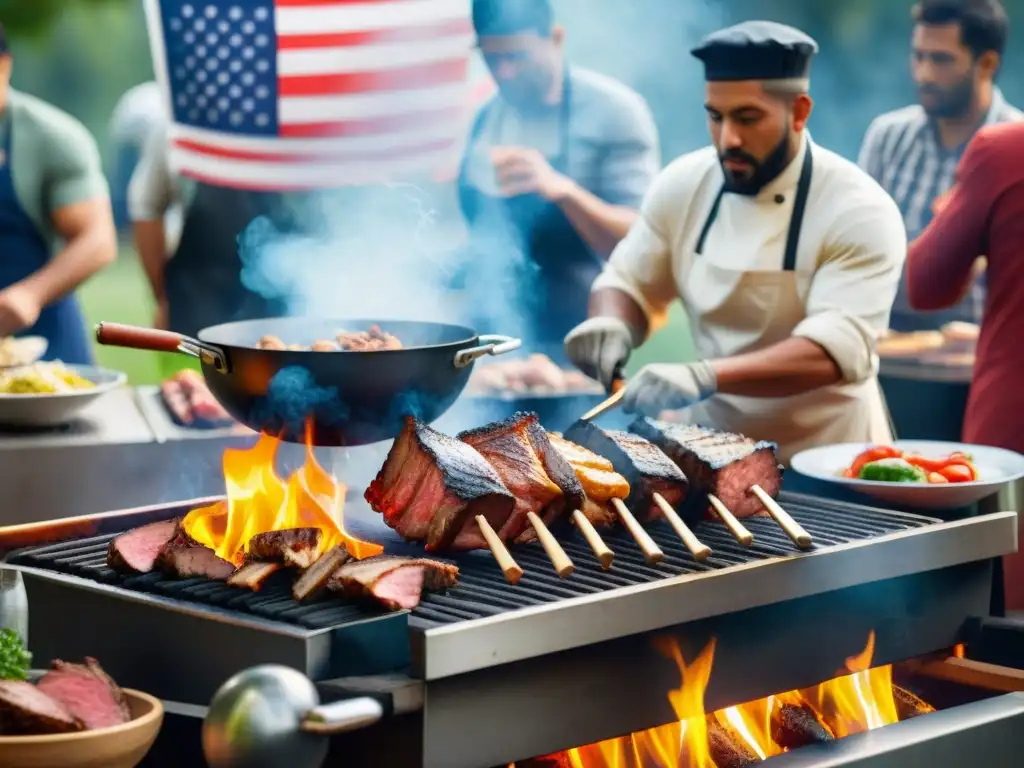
791, 440, 1024, 509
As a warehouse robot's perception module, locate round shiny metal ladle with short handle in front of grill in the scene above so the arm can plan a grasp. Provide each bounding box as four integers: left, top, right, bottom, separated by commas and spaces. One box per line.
203, 664, 384, 768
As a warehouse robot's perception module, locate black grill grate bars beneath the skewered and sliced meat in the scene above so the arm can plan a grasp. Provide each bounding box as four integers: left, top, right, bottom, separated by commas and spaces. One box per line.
7, 494, 939, 630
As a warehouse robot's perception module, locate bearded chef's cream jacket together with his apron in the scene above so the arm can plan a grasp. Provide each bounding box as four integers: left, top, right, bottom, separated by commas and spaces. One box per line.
593, 135, 907, 461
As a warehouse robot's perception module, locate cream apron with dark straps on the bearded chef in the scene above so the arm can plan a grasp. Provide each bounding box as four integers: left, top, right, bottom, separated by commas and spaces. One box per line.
680, 141, 892, 464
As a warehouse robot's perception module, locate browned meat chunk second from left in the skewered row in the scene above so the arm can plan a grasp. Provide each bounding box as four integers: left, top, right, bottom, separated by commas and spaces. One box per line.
455, 413, 584, 549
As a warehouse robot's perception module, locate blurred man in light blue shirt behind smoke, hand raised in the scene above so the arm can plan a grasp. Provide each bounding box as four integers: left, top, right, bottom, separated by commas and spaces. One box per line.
458, 0, 660, 357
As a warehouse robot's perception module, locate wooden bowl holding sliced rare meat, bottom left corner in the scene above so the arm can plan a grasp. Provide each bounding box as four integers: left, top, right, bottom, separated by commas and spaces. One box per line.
0, 688, 164, 768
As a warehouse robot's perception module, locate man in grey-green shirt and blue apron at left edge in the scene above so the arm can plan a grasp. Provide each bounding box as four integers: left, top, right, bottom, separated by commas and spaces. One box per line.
0, 20, 117, 364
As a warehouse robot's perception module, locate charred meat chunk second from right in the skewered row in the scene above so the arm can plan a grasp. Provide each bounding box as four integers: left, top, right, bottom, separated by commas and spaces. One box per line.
565, 422, 687, 519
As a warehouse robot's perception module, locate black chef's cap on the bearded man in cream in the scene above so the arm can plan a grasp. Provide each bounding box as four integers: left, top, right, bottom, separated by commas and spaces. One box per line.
690, 22, 818, 82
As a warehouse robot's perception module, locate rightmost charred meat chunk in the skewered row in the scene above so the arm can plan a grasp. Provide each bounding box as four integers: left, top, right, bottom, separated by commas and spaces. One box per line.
630, 418, 782, 517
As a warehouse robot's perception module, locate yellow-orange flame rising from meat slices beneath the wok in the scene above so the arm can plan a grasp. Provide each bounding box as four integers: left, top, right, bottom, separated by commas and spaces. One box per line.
181, 430, 384, 565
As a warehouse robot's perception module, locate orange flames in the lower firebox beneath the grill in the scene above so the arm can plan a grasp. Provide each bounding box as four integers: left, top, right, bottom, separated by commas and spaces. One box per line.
552, 632, 913, 768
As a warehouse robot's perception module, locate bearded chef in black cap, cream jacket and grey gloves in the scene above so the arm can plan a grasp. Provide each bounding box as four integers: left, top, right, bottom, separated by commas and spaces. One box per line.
565, 22, 906, 461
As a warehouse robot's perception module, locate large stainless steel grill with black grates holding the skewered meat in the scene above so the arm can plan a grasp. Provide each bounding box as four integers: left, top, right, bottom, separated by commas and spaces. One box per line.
0, 494, 1017, 768
